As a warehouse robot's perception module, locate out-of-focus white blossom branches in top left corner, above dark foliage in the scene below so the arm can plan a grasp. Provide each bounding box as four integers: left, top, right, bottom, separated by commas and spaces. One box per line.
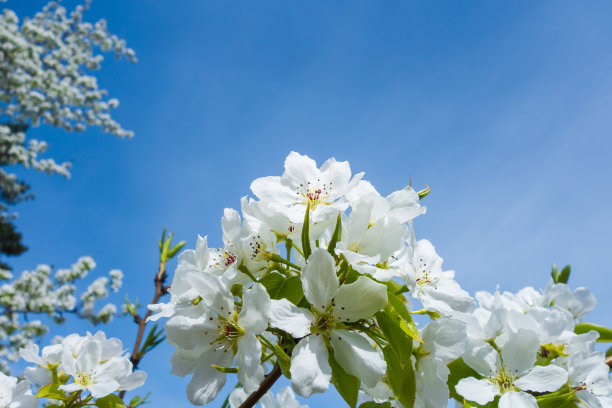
0, 1, 136, 137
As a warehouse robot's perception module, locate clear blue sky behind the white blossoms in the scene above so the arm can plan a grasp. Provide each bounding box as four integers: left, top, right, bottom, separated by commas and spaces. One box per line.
5, 0, 612, 407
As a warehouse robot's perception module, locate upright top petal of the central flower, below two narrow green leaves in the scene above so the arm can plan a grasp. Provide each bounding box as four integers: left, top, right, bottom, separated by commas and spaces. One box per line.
302, 248, 339, 311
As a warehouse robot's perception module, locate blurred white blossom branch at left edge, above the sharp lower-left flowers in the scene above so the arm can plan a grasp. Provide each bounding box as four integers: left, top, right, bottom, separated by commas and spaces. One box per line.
0, 256, 122, 372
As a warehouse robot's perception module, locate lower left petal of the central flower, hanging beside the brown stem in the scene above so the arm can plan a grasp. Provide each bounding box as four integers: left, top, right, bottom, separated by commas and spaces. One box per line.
291, 335, 331, 397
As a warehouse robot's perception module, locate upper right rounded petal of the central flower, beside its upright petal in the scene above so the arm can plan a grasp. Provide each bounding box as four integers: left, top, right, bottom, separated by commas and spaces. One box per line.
334, 276, 387, 322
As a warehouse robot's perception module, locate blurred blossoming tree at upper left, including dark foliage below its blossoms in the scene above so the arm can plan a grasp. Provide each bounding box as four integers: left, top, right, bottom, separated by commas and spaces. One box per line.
0, 1, 136, 269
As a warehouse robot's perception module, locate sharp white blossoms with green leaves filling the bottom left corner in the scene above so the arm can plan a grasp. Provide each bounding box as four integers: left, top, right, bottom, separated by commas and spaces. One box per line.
0, 331, 146, 408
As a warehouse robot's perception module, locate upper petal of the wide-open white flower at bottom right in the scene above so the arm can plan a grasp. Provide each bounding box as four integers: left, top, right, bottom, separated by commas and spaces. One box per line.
502, 329, 540, 375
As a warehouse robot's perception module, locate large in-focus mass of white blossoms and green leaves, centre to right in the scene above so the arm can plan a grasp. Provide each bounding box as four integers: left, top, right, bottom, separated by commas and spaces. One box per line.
149, 152, 611, 408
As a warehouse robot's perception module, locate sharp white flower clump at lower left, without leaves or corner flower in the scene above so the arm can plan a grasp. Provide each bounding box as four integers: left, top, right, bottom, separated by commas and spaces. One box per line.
19, 331, 146, 398
